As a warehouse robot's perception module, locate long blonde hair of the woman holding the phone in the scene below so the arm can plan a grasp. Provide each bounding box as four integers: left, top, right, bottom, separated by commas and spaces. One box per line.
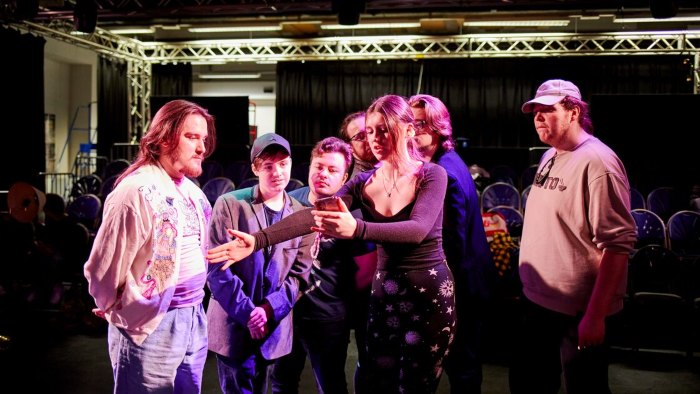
367, 94, 421, 174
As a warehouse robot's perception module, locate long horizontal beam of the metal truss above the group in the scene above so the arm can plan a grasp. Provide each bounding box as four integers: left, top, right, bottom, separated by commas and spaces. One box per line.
138, 31, 700, 63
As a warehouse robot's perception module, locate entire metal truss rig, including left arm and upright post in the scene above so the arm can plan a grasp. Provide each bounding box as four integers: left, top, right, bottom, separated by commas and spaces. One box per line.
9, 22, 700, 135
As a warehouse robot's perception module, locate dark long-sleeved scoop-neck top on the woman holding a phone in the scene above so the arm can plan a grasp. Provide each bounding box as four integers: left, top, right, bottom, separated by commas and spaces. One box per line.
253, 163, 447, 269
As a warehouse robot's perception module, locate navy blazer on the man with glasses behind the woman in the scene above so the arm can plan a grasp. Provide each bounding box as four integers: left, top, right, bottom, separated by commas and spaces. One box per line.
432, 150, 498, 298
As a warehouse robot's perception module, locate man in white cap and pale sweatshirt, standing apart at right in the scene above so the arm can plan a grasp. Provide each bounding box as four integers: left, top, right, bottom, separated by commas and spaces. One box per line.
510, 79, 636, 394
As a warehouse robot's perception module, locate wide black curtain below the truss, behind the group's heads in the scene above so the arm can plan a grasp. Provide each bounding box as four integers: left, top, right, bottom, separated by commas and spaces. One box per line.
276, 56, 693, 150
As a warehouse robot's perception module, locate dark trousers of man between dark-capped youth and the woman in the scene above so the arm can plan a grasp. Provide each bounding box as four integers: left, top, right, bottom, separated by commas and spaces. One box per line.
271, 315, 350, 394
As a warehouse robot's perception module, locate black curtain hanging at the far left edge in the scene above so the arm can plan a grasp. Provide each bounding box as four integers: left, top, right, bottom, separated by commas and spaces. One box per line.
0, 26, 46, 190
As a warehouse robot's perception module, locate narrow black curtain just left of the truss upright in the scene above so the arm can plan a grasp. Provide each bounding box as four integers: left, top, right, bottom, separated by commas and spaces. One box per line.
97, 57, 131, 158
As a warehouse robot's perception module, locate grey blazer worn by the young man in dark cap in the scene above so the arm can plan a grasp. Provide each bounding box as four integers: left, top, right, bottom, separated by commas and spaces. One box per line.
207, 185, 311, 360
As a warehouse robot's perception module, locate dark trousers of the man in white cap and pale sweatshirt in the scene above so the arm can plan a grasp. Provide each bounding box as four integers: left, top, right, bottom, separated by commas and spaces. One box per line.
509, 296, 610, 394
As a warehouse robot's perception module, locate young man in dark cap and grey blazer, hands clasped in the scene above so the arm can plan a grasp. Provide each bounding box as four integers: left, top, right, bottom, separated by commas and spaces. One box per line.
207, 133, 313, 393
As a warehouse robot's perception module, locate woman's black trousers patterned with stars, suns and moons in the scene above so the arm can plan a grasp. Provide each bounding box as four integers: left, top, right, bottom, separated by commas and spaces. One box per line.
367, 262, 457, 394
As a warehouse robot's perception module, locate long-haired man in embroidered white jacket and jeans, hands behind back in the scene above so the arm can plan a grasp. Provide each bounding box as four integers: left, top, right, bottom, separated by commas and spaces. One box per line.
84, 100, 215, 393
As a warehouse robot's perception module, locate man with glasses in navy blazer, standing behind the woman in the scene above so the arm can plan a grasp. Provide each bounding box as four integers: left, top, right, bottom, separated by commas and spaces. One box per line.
408, 94, 497, 394
